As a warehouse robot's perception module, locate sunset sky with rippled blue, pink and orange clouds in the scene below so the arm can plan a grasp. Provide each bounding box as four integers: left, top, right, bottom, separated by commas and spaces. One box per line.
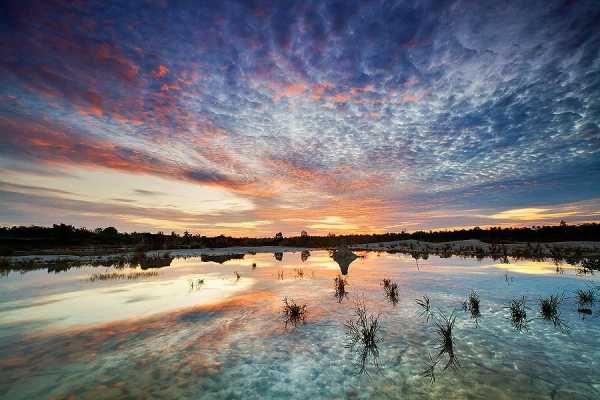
0, 0, 600, 236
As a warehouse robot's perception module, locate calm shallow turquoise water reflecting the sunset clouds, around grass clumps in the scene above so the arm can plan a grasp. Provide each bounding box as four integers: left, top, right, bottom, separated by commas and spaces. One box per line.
0, 251, 600, 399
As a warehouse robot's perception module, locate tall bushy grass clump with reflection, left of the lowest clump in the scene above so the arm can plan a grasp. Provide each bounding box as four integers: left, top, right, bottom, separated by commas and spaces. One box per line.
344, 300, 383, 375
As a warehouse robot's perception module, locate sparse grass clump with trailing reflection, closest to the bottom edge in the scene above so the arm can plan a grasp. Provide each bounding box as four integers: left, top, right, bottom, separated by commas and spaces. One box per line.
421, 312, 460, 383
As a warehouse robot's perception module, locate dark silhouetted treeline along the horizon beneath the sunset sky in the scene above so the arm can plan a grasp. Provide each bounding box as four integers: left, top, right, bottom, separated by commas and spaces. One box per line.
0, 222, 600, 253
